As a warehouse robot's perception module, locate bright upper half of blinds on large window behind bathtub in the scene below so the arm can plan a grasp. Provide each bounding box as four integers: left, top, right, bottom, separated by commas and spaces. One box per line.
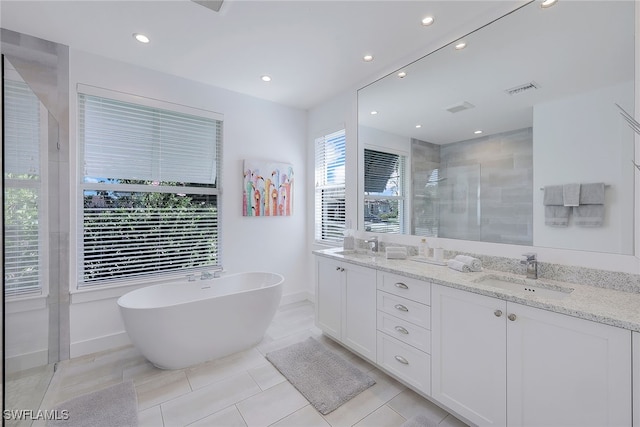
79, 94, 221, 184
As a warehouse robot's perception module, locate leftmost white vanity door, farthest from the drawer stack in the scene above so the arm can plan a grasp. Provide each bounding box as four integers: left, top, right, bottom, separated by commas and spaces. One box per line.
316, 257, 344, 340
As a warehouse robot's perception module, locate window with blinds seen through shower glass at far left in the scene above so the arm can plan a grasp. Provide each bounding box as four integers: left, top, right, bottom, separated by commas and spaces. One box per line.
3, 77, 45, 297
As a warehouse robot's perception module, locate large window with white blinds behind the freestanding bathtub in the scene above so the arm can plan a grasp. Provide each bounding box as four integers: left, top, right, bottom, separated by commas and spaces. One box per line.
78, 88, 222, 286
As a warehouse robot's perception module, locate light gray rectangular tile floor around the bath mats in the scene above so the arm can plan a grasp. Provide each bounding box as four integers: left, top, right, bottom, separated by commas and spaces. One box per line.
22, 302, 466, 427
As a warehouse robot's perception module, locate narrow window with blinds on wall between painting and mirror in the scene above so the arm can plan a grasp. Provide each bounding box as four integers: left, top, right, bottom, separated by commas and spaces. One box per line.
315, 130, 346, 242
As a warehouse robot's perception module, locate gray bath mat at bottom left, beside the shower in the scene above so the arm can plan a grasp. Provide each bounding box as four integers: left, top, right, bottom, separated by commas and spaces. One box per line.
47, 381, 138, 427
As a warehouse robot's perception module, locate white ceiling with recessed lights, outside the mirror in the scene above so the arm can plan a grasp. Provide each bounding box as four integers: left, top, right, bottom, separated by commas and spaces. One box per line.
0, 0, 526, 109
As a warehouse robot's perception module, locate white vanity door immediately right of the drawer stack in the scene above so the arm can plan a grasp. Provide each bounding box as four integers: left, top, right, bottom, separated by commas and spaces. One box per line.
431, 285, 506, 426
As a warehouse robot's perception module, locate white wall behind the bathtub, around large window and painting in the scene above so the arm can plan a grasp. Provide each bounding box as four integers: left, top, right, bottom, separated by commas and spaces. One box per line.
69, 50, 311, 357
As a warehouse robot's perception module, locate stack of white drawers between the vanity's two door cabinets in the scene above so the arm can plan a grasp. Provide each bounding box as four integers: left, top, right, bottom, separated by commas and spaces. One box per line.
377, 271, 431, 395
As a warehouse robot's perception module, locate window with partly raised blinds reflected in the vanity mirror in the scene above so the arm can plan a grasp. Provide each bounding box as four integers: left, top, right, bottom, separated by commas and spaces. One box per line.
364, 148, 407, 233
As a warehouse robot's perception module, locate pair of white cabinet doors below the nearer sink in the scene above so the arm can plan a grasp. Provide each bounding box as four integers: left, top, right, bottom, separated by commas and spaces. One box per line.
431, 285, 632, 427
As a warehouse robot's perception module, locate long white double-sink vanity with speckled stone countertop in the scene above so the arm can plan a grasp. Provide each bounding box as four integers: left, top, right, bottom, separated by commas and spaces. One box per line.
314, 249, 640, 427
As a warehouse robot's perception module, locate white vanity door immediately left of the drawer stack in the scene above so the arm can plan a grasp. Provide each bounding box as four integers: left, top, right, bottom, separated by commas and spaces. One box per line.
342, 265, 377, 362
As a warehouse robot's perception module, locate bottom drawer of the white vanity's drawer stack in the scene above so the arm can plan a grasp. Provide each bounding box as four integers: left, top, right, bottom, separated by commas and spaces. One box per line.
378, 331, 431, 396
